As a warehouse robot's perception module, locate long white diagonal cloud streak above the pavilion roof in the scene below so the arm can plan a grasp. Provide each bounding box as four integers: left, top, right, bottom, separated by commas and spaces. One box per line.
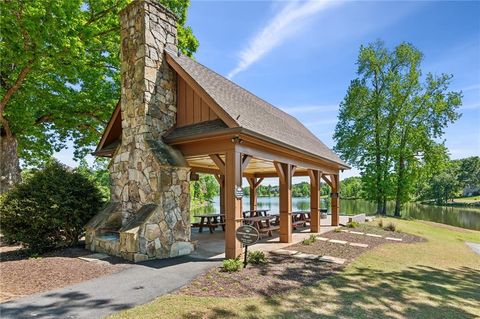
227, 0, 340, 79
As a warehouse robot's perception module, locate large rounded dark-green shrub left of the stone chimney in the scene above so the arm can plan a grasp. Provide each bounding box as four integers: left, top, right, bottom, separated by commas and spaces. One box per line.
0, 161, 103, 253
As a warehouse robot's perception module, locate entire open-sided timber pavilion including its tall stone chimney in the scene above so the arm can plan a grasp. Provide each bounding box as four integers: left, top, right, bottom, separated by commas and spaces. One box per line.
91, 0, 349, 261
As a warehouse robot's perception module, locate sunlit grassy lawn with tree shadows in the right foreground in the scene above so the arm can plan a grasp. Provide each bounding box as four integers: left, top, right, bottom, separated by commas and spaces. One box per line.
112, 220, 480, 319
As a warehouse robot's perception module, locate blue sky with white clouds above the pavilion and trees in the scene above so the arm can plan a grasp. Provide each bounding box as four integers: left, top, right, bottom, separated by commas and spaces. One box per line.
57, 0, 480, 184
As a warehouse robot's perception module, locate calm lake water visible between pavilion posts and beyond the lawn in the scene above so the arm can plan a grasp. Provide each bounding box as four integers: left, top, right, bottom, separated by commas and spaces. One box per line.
192, 197, 480, 230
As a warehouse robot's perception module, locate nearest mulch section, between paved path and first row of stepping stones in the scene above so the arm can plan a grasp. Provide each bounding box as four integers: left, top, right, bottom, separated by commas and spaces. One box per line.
176, 255, 343, 297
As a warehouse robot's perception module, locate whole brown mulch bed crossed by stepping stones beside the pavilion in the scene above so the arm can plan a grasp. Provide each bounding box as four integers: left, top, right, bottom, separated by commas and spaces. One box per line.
176, 224, 425, 297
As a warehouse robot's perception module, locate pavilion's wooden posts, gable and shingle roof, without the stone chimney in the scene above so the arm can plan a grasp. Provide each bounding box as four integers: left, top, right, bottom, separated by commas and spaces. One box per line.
96, 51, 349, 258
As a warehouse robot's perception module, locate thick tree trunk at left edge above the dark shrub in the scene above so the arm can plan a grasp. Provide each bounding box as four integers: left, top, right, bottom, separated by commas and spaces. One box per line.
0, 135, 20, 194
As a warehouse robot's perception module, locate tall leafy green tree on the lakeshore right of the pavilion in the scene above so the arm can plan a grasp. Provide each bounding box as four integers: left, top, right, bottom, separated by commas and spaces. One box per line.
334, 41, 461, 216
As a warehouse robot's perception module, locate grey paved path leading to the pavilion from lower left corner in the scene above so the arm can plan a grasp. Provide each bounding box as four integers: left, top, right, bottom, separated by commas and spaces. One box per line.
0, 257, 220, 319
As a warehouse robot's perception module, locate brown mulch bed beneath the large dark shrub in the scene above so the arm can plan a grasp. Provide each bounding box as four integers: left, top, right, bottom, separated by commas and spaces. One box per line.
0, 245, 126, 302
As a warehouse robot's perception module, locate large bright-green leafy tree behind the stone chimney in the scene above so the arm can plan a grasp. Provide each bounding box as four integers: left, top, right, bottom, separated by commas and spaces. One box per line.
0, 0, 198, 192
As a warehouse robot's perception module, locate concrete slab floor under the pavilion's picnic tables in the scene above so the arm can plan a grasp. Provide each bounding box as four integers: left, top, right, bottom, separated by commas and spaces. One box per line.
190, 215, 348, 259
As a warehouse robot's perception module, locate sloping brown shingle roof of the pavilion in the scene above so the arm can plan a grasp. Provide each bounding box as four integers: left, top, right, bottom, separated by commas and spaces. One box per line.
166, 51, 348, 167
